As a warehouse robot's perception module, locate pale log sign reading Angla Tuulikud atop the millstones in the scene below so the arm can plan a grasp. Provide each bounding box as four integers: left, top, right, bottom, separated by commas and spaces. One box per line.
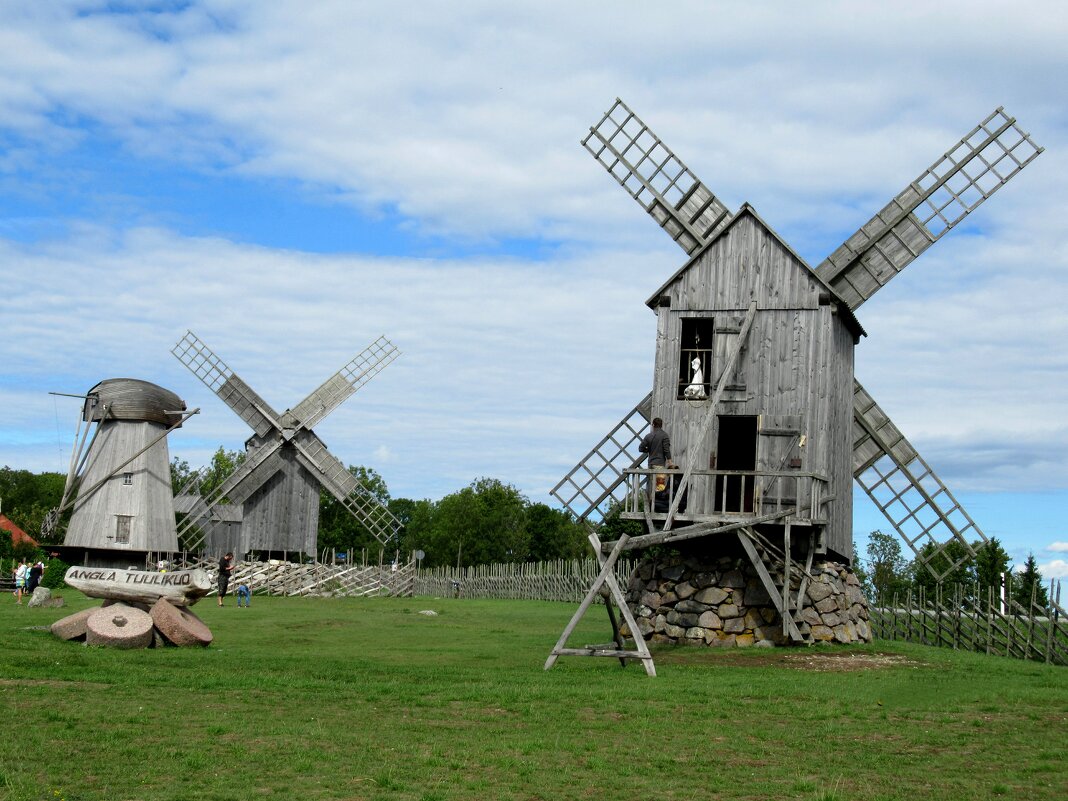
64, 567, 211, 607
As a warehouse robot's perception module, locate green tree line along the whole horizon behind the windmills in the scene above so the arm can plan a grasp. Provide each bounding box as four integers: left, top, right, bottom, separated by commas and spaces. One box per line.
0, 457, 1049, 607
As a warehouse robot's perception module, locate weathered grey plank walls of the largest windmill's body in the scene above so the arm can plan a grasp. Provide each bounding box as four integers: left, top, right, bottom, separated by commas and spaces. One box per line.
648, 206, 861, 561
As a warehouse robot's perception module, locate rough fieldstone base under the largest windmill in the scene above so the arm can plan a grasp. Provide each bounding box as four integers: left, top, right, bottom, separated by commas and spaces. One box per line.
624, 554, 871, 647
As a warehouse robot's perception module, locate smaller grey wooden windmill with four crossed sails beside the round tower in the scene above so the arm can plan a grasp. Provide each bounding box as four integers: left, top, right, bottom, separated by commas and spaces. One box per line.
171, 331, 401, 553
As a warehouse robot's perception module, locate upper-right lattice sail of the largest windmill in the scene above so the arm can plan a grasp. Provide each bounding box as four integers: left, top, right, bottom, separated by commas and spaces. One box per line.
816, 107, 1043, 310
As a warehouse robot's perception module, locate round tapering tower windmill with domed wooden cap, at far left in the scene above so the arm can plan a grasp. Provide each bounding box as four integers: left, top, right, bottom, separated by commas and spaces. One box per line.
45, 378, 199, 565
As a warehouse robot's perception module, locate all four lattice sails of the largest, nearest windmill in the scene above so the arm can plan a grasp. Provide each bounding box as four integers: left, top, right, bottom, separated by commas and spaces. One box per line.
552, 99, 1042, 579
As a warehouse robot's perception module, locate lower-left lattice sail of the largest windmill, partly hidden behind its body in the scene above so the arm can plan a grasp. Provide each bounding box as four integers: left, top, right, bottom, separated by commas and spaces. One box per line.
550, 392, 653, 522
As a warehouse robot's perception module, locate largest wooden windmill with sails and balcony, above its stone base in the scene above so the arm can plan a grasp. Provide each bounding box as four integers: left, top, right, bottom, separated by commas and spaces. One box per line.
552, 100, 1041, 674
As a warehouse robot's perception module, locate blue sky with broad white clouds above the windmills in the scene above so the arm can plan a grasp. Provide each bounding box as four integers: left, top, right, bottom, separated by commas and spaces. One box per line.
0, 0, 1068, 578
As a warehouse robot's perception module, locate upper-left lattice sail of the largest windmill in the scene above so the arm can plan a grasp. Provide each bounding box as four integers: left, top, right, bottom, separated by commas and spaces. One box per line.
582, 98, 733, 254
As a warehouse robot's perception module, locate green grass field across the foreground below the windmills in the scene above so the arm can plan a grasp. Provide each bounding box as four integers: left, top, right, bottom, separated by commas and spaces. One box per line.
0, 591, 1068, 801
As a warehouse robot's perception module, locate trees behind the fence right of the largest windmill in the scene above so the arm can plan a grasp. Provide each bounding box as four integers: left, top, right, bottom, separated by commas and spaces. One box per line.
853, 531, 1050, 609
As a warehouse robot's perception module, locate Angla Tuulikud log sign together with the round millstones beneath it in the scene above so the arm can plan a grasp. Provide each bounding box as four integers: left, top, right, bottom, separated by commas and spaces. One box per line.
51, 567, 213, 648
